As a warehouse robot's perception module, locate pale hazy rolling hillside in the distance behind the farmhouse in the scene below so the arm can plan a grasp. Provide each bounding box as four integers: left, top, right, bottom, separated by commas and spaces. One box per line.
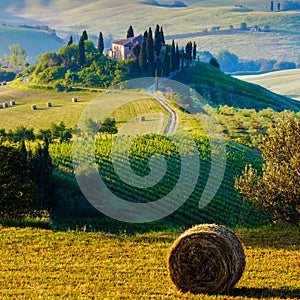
0, 0, 300, 61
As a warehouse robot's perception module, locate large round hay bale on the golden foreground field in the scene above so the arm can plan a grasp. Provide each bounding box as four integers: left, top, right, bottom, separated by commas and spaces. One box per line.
168, 224, 246, 294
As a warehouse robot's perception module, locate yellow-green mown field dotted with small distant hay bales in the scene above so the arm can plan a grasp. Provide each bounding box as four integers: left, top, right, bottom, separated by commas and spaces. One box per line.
0, 86, 169, 134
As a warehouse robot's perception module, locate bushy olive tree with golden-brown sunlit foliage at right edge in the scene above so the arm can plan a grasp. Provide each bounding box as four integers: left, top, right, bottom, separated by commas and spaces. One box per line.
235, 115, 300, 225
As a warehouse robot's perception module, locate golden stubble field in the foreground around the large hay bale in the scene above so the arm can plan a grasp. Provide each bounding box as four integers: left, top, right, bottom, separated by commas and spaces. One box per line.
0, 227, 300, 300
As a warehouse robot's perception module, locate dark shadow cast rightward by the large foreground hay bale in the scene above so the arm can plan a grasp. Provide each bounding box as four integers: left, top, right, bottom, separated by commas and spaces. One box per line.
226, 287, 300, 299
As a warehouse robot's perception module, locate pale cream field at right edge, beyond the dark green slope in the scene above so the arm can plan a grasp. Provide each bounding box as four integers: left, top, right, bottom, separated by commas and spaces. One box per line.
236, 69, 300, 100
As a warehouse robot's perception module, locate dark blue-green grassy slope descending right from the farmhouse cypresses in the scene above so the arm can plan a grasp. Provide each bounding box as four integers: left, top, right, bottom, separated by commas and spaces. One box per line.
173, 62, 300, 111
